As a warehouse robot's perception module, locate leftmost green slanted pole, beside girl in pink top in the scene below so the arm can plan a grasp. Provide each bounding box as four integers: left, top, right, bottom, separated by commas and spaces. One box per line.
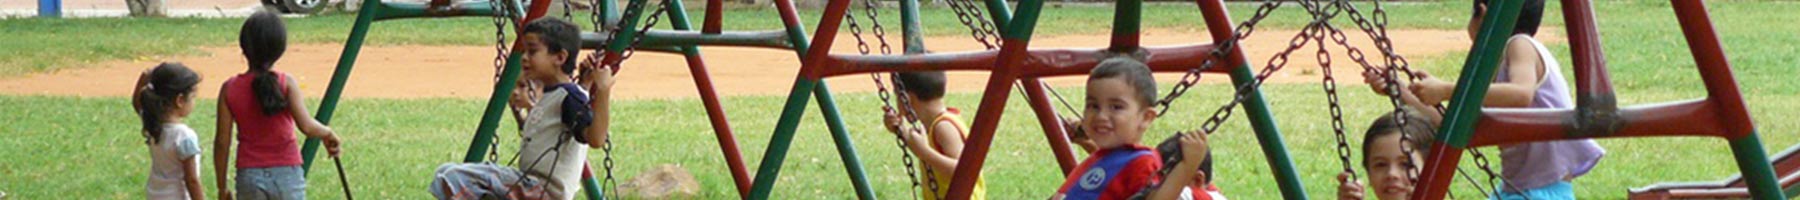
301, 0, 382, 171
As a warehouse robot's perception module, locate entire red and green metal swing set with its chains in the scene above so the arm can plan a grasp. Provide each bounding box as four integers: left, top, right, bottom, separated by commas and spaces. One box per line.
273, 0, 1796, 200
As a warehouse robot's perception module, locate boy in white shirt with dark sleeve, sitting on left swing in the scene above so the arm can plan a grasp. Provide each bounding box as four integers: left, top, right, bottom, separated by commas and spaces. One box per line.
430, 18, 612, 200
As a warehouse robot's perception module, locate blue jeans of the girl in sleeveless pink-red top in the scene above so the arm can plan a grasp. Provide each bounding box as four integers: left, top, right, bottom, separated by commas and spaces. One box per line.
236, 166, 306, 200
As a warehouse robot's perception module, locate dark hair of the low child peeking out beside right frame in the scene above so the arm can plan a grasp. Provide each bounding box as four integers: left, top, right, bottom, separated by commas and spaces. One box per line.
1363, 108, 1438, 164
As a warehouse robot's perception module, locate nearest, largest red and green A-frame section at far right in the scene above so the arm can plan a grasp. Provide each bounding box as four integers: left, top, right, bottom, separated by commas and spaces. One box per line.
1413, 0, 1786, 200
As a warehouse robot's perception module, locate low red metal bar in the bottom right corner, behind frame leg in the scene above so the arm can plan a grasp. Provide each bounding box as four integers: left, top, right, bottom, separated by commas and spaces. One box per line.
1629, 144, 1800, 200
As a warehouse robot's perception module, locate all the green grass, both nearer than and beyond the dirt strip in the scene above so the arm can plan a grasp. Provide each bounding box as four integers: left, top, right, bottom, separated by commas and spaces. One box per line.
0, 2, 1800, 200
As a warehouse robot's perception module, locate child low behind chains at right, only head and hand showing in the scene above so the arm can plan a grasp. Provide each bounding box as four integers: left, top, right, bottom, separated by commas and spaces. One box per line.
1337, 110, 1436, 200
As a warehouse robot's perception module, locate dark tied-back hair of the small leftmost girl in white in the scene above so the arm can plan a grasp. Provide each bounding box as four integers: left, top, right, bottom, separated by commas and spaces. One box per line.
133, 63, 200, 144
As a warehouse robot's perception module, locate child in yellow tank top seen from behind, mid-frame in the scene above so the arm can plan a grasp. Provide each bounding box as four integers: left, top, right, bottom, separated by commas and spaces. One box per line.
884, 70, 986, 200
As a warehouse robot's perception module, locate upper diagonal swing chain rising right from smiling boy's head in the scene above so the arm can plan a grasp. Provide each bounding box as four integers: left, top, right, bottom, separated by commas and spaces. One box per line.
1156, 0, 1298, 114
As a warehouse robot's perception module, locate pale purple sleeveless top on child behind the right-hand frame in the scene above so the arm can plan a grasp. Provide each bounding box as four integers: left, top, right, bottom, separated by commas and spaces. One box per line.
1494, 34, 1606, 191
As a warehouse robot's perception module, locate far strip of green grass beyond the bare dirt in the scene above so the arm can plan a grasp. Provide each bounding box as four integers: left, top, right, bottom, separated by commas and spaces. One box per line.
0, 4, 1458, 77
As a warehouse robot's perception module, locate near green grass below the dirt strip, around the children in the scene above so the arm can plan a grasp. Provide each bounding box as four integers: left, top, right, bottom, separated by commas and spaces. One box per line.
0, 85, 1800, 200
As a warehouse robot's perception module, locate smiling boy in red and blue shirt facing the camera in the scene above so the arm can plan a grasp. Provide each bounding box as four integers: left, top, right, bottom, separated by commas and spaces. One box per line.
1051, 58, 1206, 200
